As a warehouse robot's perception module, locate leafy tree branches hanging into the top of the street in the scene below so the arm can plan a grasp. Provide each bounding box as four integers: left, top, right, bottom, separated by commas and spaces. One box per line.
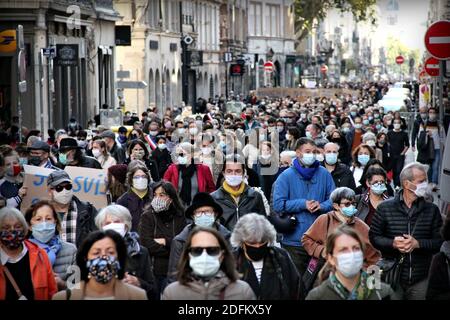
294, 0, 377, 41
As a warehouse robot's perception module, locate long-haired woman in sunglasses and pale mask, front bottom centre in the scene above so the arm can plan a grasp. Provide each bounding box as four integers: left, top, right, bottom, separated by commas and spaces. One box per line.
162, 227, 255, 300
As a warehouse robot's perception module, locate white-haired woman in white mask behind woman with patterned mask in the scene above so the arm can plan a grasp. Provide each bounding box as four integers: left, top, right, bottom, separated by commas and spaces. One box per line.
95, 204, 159, 299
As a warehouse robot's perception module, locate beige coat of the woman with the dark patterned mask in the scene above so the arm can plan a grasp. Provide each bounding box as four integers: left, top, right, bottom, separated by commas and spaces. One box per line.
52, 280, 147, 300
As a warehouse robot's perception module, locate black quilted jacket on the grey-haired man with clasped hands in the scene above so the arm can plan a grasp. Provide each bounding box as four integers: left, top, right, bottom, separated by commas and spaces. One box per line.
369, 191, 442, 286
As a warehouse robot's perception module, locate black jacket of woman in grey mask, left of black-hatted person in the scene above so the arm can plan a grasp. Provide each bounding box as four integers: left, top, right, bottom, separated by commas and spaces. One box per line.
139, 208, 186, 276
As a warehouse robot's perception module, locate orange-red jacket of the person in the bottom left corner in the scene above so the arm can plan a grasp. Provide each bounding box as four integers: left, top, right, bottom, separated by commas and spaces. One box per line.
0, 240, 58, 300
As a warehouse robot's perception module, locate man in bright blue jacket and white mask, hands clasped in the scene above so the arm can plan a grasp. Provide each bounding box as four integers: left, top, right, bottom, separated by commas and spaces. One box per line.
273, 138, 335, 275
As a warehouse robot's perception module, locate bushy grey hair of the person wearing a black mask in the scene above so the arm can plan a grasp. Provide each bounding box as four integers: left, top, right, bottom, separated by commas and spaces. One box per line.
230, 213, 277, 247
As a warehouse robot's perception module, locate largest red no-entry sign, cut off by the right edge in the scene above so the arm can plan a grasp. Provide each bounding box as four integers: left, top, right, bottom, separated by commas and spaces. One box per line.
425, 20, 450, 60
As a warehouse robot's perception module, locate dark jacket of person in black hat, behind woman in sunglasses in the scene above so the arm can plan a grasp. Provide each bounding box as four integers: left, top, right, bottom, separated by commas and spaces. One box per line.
167, 222, 231, 283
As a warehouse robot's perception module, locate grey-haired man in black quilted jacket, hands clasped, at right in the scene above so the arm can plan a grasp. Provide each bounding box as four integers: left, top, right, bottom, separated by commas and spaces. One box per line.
369, 162, 443, 300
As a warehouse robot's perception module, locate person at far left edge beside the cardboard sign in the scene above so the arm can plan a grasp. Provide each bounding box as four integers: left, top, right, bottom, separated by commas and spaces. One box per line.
0, 147, 27, 208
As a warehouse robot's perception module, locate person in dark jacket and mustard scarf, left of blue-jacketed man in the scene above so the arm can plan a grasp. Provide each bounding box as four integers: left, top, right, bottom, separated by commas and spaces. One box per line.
211, 155, 268, 231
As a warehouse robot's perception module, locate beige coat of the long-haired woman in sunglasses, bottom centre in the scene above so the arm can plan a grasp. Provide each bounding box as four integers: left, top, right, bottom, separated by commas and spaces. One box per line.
162, 272, 256, 300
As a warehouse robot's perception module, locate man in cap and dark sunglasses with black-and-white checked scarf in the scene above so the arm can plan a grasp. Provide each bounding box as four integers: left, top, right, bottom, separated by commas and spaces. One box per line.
47, 170, 97, 247
